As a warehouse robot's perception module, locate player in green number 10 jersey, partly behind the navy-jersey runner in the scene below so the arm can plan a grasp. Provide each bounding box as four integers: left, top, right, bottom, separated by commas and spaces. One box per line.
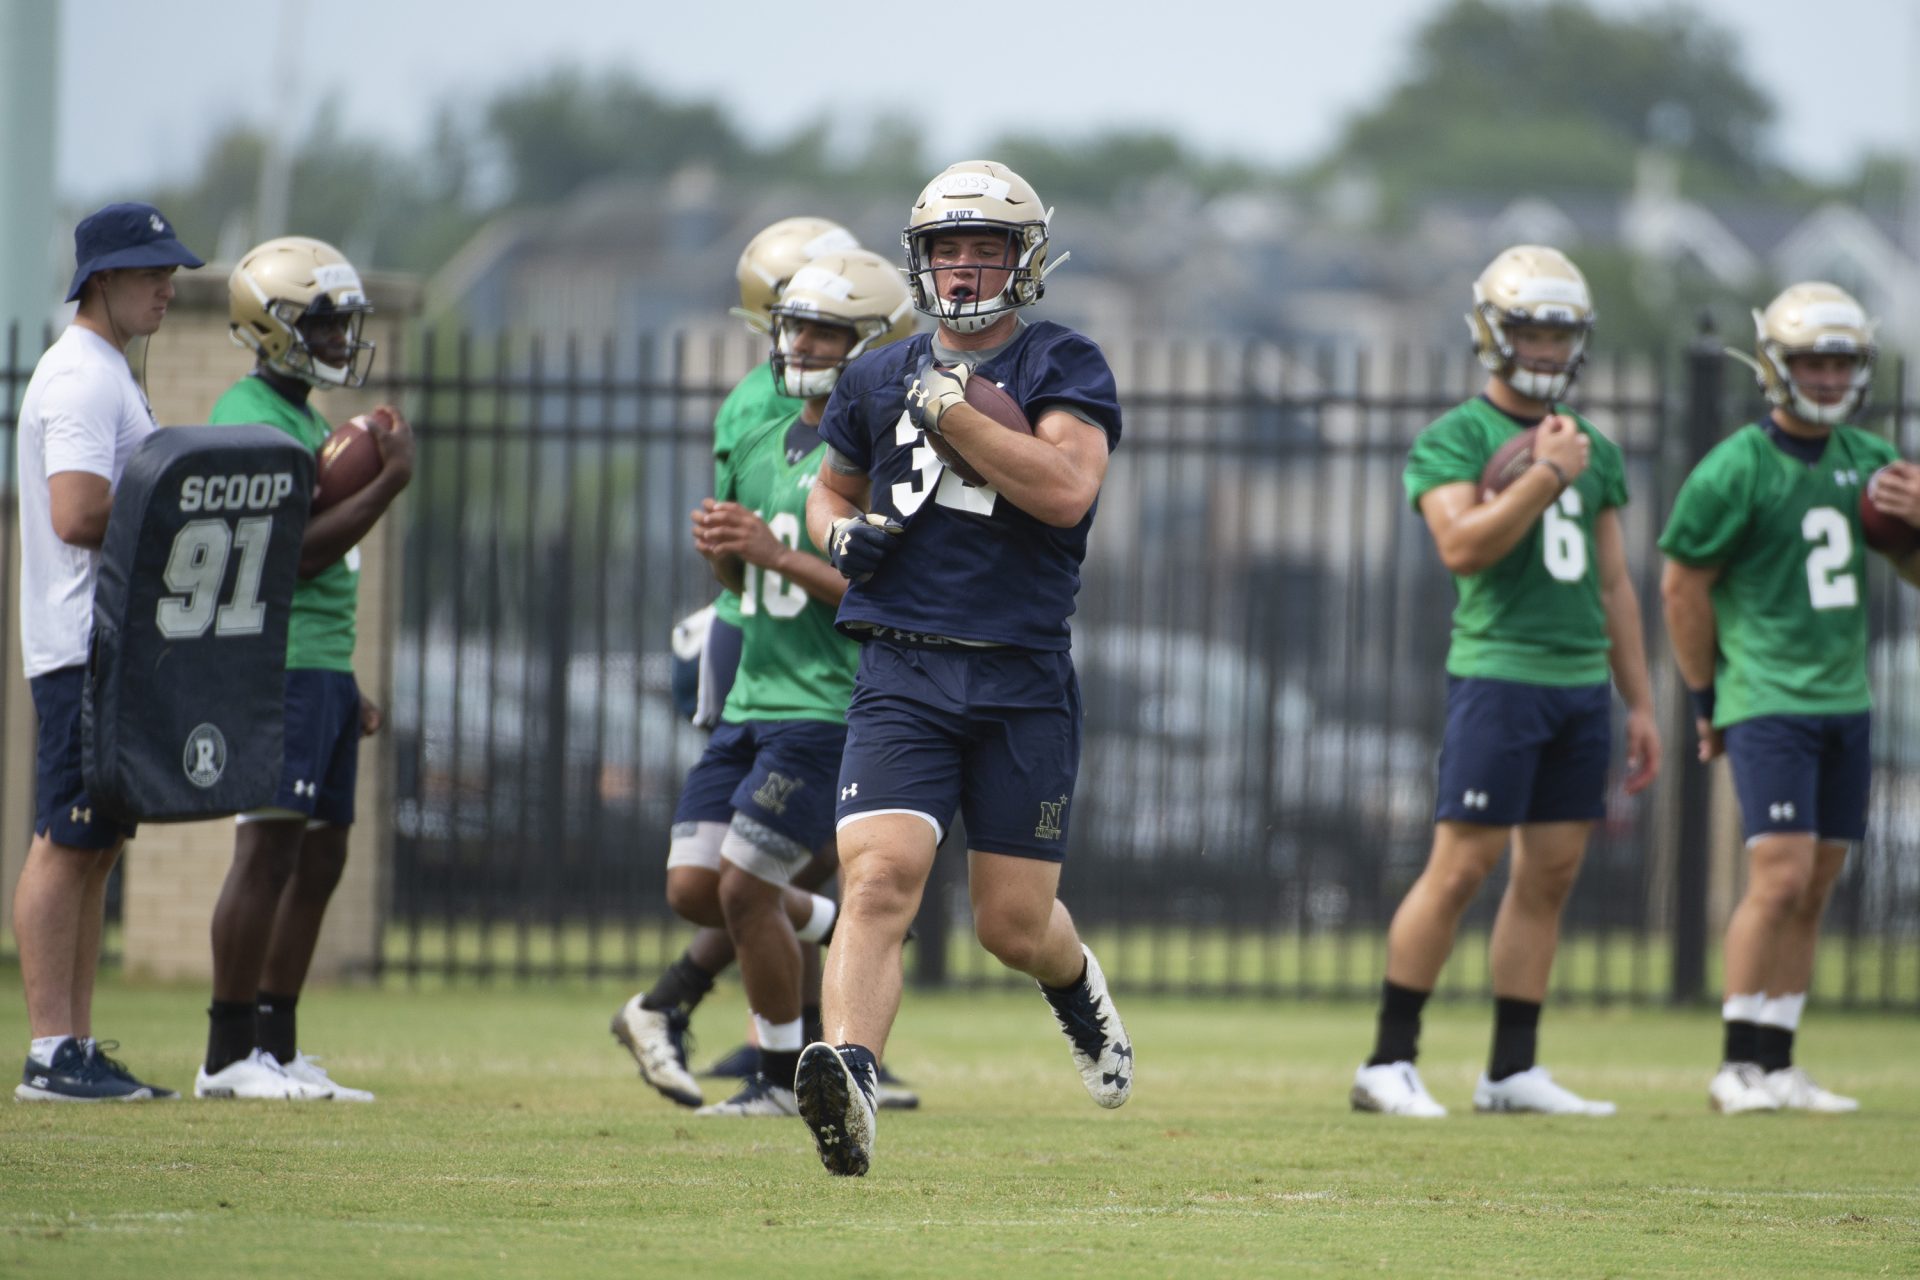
668, 249, 914, 1115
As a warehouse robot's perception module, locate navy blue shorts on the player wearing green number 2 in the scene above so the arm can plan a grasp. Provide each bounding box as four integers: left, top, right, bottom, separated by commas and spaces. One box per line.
1722, 712, 1874, 841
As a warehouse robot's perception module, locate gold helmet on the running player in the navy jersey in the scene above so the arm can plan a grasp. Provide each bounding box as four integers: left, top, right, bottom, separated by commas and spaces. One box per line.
900, 159, 1068, 334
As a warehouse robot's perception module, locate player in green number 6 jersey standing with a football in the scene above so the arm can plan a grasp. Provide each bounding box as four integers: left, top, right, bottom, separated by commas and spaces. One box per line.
1352, 246, 1661, 1117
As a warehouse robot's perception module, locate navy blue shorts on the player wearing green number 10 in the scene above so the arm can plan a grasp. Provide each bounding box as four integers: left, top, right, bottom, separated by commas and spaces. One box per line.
674, 720, 847, 848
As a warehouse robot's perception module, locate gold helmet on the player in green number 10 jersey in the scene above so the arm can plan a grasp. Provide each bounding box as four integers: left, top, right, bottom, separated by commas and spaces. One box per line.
772, 249, 914, 399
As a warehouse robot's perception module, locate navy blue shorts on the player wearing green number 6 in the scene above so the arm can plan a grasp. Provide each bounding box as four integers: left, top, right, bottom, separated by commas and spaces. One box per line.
1434, 676, 1613, 827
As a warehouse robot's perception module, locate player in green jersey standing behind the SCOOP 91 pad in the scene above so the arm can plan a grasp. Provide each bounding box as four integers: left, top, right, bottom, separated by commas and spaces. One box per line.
194, 236, 413, 1102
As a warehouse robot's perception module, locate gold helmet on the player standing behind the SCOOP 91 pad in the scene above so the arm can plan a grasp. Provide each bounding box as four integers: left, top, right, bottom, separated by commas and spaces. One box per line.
227, 236, 374, 388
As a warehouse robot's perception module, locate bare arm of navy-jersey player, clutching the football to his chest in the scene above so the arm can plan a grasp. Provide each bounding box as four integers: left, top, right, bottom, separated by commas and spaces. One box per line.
941, 403, 1108, 530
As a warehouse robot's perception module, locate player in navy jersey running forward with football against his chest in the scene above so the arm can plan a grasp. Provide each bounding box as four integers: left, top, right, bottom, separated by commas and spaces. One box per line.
797, 161, 1133, 1174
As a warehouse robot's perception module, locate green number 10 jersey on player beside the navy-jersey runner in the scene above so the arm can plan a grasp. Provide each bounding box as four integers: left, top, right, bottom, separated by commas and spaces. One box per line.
716, 413, 860, 723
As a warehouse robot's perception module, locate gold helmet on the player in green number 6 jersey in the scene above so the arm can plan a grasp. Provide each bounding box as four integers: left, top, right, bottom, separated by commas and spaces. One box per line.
1467, 244, 1596, 401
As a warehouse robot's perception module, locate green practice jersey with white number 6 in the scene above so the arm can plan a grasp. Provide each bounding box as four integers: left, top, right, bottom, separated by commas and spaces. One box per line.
1402, 399, 1626, 687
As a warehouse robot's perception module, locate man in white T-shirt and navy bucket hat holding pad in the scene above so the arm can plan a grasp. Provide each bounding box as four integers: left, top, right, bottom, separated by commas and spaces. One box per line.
13, 203, 202, 1102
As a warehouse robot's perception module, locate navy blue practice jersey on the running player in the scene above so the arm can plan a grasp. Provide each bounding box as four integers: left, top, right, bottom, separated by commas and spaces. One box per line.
820, 320, 1119, 649
